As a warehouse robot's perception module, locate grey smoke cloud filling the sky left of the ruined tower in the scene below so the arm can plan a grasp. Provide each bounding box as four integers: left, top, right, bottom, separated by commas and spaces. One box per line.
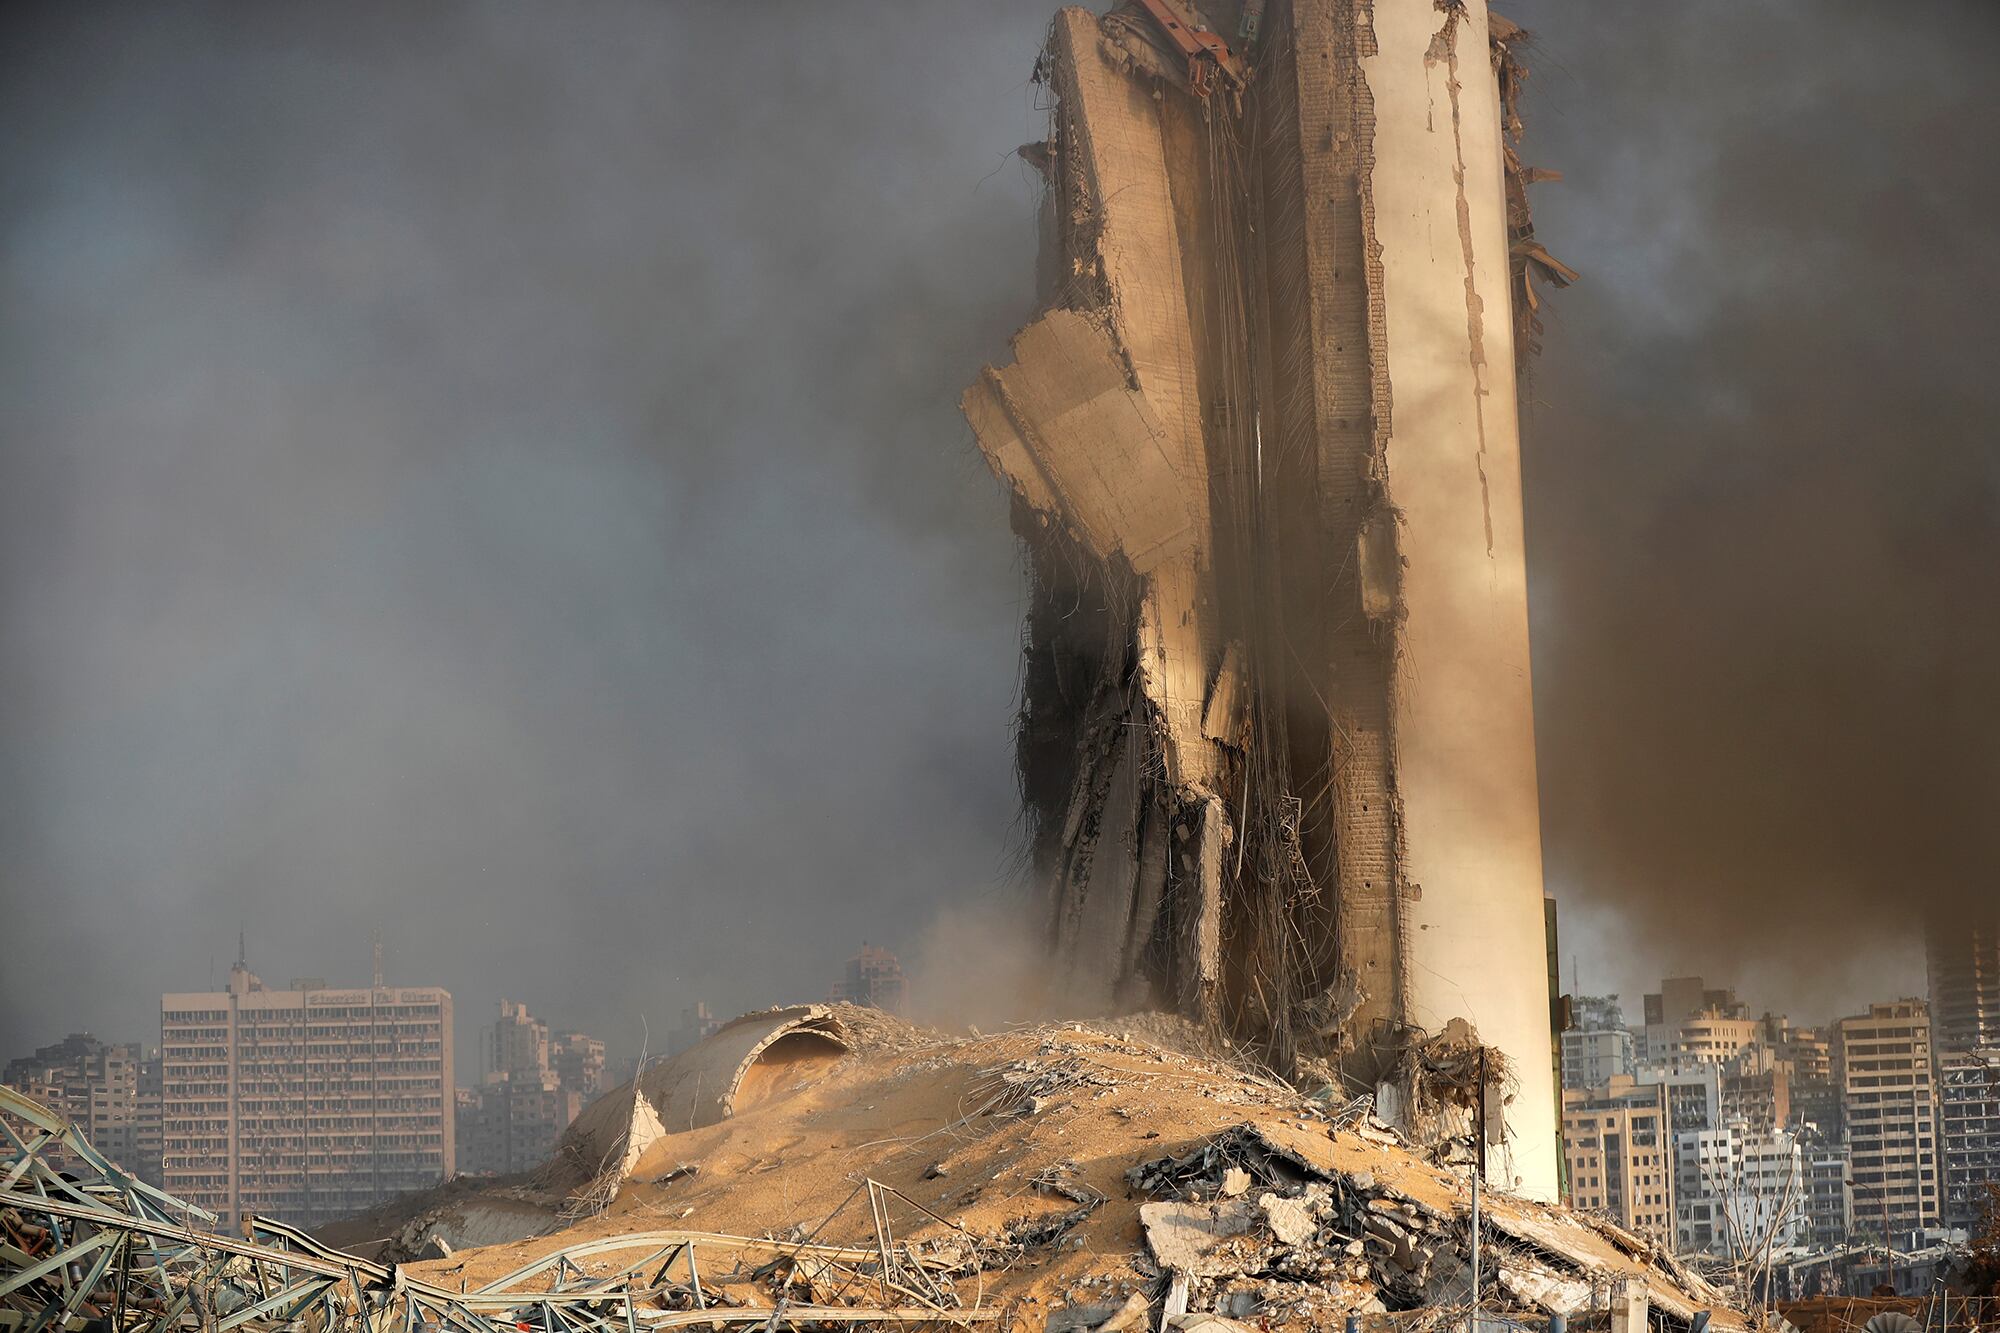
0, 0, 1048, 1083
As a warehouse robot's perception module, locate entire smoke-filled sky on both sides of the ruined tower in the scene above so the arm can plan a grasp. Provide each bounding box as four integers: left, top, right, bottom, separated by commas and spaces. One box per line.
0, 0, 2000, 1075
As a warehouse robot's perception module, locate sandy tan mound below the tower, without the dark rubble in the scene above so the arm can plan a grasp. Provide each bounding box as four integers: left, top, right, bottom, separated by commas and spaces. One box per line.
410, 1019, 1450, 1327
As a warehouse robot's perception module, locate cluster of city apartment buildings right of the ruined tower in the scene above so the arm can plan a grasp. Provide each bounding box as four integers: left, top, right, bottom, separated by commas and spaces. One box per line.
1560, 924, 2000, 1299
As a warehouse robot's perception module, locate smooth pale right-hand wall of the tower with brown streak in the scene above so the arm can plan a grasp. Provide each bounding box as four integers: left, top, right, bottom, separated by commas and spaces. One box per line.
1362, 0, 1558, 1199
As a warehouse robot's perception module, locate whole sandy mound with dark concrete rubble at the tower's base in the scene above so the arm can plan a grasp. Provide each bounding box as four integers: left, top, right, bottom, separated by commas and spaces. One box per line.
324, 1009, 1742, 1331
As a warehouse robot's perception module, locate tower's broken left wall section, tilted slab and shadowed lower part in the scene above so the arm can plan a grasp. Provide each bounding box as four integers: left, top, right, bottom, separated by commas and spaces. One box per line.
962, 8, 1228, 1009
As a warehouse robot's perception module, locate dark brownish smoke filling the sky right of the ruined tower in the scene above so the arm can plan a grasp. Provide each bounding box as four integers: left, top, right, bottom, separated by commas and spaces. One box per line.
1508, 2, 2000, 1005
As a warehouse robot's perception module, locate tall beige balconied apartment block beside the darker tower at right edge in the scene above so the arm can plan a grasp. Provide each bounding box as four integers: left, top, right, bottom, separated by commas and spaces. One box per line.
1832, 999, 1942, 1243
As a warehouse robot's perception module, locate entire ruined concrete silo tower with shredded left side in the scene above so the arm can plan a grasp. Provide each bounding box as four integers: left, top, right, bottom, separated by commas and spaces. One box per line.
962, 0, 1574, 1195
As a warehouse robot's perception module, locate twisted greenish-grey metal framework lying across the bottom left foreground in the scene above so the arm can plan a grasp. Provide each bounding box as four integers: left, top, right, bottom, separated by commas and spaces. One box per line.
0, 1087, 998, 1333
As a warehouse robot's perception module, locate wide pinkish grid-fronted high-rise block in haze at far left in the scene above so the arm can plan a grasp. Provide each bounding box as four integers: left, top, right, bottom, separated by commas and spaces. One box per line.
160, 959, 456, 1227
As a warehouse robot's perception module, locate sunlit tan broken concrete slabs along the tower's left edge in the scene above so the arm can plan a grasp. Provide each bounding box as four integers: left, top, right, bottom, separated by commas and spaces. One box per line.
962, 8, 1240, 1015
